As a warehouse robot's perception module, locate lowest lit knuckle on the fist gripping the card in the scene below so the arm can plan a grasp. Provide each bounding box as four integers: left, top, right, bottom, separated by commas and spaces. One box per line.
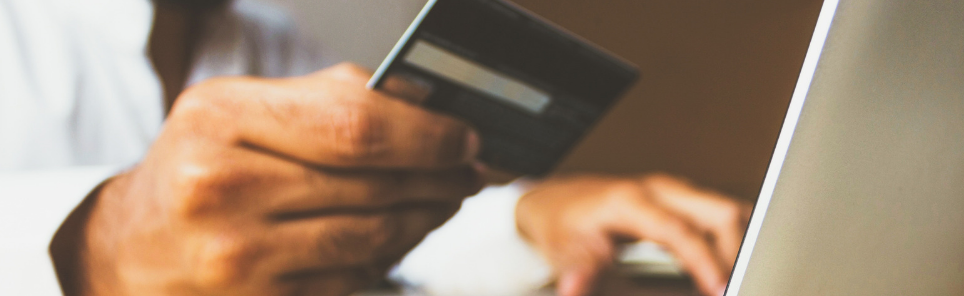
196, 235, 261, 288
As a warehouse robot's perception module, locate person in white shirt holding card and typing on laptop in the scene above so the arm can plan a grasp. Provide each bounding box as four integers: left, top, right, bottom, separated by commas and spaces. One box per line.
0, 0, 749, 296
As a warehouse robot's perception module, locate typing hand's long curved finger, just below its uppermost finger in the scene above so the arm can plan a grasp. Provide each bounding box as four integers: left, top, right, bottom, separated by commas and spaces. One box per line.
613, 201, 726, 295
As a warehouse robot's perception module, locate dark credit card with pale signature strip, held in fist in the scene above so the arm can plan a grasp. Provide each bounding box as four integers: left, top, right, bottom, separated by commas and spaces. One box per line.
368, 0, 639, 176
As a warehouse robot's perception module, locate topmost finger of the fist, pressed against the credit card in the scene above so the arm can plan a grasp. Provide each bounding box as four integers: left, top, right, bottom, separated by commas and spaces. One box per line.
171, 66, 479, 169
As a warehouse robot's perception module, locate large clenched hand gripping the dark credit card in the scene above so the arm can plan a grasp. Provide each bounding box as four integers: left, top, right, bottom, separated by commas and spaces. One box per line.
58, 64, 482, 295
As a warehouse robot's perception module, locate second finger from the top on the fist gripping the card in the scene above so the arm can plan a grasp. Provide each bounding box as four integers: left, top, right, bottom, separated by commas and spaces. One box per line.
176, 148, 482, 220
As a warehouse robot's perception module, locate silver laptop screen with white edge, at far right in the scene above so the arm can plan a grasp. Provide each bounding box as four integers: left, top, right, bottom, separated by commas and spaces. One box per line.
726, 0, 964, 296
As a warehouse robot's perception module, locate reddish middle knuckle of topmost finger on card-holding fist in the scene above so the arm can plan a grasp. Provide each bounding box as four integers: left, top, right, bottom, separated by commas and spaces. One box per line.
331, 103, 387, 161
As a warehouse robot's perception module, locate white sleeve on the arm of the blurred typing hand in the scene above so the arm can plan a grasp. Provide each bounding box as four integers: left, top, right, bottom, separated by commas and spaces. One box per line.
389, 182, 552, 295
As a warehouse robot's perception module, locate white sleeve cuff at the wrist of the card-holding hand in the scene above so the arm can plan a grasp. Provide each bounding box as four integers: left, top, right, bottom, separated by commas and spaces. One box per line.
0, 166, 120, 296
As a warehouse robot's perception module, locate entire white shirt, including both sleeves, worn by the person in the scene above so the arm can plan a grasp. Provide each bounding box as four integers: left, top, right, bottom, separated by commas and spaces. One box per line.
0, 0, 549, 295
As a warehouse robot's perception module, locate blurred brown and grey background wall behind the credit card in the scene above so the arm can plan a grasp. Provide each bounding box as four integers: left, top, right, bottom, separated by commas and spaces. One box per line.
254, 0, 822, 200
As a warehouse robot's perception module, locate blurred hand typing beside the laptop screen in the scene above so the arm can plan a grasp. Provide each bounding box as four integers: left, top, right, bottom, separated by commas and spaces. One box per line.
516, 174, 752, 296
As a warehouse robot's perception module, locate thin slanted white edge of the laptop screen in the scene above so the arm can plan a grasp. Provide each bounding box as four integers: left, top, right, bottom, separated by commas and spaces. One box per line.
724, 0, 839, 296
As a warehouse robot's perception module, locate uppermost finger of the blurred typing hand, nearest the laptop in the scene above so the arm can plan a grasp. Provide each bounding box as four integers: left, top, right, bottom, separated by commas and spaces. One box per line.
644, 175, 750, 269
